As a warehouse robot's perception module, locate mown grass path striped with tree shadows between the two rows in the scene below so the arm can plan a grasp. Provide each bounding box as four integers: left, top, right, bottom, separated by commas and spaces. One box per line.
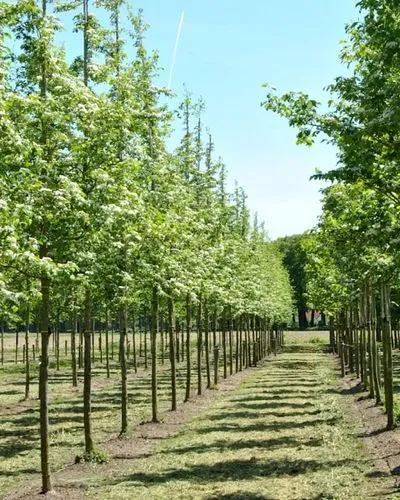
66, 350, 383, 499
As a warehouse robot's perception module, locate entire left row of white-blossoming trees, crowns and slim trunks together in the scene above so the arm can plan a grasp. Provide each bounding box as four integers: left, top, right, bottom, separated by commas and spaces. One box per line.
0, 0, 291, 492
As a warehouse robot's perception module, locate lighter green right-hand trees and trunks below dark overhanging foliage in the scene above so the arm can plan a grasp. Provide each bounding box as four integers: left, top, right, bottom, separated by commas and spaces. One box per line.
304, 191, 399, 429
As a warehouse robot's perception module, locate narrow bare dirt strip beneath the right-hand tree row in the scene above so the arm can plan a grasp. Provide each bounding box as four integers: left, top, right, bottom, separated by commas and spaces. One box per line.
341, 376, 400, 494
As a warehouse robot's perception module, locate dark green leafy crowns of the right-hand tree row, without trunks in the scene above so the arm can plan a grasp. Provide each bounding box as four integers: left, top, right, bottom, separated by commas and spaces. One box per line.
263, 0, 400, 315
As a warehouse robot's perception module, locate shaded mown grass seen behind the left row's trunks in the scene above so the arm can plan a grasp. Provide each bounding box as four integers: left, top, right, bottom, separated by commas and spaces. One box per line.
0, 334, 227, 498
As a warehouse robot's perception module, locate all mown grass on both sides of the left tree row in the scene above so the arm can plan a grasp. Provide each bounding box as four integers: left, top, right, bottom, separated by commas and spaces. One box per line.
0, 332, 390, 499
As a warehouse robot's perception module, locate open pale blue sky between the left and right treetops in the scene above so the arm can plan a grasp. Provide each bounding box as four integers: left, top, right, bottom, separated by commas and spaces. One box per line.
60, 0, 358, 238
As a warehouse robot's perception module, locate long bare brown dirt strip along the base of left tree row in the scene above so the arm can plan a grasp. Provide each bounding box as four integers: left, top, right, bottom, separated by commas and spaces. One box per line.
5, 361, 262, 500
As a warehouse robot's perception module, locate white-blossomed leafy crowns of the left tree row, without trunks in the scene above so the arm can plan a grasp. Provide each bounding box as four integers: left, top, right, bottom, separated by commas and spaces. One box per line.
0, 1, 291, 328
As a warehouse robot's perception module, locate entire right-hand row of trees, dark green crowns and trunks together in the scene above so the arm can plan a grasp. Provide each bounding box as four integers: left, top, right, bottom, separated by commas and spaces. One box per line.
264, 0, 400, 428
